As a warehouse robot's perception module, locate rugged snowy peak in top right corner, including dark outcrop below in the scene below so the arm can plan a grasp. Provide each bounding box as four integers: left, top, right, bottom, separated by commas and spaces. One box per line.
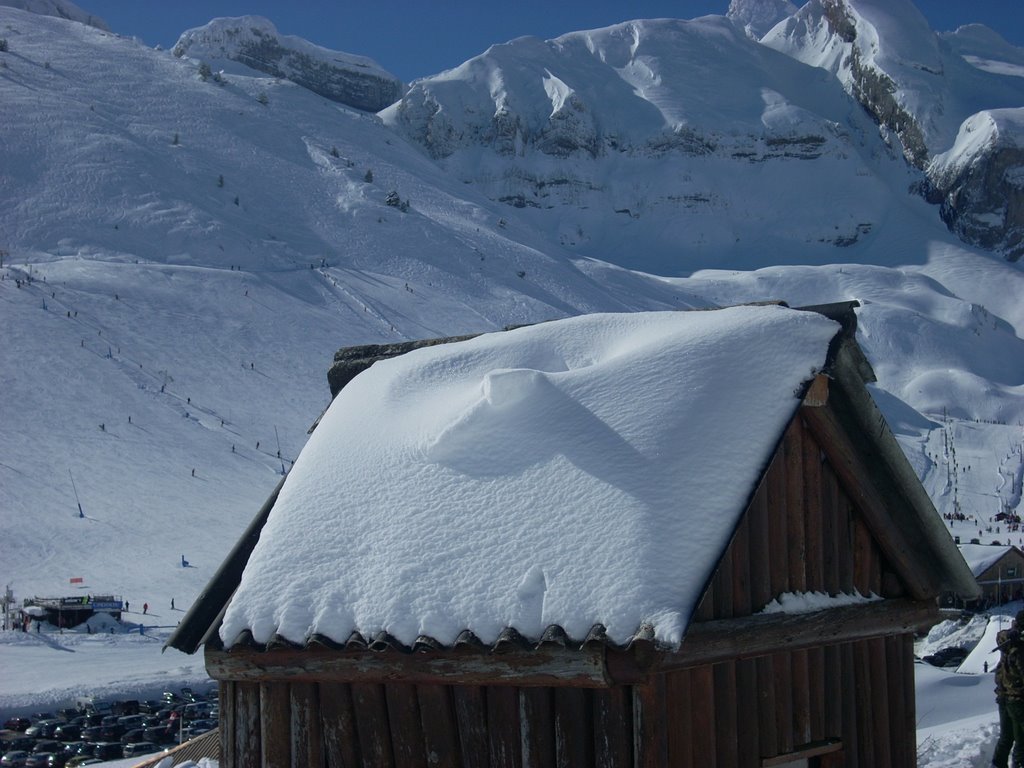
761, 0, 1024, 259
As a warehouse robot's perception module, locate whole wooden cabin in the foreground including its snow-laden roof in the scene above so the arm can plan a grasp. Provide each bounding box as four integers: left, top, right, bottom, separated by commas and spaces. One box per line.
169, 303, 977, 768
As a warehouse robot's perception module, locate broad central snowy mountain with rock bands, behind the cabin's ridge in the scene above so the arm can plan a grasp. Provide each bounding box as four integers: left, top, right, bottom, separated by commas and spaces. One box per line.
381, 16, 935, 274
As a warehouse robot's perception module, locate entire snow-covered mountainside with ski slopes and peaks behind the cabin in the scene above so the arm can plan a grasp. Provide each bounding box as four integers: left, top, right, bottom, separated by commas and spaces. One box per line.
0, 0, 1024, 741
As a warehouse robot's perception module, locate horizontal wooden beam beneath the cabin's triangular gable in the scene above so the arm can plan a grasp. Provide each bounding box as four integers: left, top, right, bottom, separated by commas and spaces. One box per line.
608, 600, 939, 680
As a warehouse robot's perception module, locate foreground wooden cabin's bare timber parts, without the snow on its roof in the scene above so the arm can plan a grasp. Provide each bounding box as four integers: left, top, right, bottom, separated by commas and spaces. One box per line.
169, 303, 977, 768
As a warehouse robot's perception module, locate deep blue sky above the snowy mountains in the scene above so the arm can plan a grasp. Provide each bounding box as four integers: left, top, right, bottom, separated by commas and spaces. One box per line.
77, 0, 1024, 82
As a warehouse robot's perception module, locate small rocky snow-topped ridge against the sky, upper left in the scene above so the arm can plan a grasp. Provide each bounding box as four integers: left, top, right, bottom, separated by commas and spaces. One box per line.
173, 16, 403, 112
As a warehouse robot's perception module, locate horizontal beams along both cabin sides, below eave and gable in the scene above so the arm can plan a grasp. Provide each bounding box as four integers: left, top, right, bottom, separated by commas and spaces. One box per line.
206, 599, 938, 688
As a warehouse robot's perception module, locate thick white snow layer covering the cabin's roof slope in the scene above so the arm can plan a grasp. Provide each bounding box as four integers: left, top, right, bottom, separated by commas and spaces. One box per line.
220, 306, 839, 645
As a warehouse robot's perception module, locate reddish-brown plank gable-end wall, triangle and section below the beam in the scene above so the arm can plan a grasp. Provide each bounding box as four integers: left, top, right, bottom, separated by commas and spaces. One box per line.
670, 416, 914, 768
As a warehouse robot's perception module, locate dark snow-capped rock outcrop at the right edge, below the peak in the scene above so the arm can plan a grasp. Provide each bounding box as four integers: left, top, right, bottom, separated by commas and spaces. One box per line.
929, 109, 1024, 261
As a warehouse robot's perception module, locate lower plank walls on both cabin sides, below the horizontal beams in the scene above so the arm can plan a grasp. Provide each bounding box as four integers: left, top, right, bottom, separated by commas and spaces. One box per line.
220, 636, 915, 768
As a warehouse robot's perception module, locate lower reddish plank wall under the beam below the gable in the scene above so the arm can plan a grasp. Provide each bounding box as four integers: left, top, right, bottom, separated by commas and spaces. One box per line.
634, 636, 916, 768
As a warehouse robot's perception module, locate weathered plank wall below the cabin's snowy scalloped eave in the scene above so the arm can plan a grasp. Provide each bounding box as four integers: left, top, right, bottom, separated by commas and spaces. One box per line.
220, 676, 634, 768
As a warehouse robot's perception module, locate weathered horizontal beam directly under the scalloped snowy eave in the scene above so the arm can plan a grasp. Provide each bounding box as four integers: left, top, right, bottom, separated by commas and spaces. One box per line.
206, 645, 610, 688
